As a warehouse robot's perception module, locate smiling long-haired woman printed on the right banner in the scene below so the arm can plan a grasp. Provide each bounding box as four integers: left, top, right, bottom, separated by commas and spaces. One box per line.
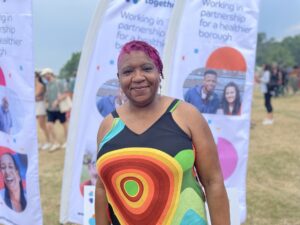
222, 82, 241, 115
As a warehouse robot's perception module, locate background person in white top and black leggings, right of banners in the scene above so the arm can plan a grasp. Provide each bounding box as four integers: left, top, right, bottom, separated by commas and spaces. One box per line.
256, 64, 274, 125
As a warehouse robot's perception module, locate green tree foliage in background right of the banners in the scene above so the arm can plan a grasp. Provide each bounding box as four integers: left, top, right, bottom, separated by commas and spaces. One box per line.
256, 33, 300, 67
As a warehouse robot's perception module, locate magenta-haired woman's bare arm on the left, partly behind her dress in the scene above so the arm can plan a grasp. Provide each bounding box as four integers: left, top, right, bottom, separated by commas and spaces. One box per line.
95, 115, 113, 225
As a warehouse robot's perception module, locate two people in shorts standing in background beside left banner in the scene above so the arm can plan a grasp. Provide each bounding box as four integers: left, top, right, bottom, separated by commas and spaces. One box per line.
35, 68, 74, 152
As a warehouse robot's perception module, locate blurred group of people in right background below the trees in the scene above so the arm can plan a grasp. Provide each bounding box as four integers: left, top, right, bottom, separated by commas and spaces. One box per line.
255, 64, 300, 125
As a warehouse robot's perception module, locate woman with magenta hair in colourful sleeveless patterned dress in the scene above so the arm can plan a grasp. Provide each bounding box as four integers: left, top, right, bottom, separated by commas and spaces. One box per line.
95, 41, 230, 225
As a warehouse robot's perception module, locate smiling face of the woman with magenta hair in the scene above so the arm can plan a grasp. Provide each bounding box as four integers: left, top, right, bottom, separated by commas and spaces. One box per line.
118, 51, 160, 106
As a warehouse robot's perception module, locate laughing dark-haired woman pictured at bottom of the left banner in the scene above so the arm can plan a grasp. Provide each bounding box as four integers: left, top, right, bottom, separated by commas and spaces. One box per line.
0, 153, 27, 212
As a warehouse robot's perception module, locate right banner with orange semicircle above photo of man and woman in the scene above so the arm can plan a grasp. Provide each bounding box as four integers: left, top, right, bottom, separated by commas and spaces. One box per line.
165, 0, 259, 222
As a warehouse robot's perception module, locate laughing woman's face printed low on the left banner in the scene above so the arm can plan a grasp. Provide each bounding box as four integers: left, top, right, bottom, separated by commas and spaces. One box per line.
0, 154, 21, 190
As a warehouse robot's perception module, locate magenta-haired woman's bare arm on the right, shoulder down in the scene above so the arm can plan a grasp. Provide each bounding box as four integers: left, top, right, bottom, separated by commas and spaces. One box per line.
174, 102, 230, 225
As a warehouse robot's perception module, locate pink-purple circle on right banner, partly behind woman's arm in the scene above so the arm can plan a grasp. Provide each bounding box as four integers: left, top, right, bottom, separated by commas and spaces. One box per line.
218, 137, 238, 180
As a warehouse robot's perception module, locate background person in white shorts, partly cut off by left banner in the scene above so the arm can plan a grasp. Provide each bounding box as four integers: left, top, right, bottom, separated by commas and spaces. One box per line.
35, 71, 51, 150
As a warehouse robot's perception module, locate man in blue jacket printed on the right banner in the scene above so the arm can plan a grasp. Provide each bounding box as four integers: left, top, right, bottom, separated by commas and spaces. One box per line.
184, 70, 220, 114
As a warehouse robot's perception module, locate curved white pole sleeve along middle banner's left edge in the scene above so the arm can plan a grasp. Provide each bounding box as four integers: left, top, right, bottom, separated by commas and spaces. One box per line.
59, 0, 109, 223
